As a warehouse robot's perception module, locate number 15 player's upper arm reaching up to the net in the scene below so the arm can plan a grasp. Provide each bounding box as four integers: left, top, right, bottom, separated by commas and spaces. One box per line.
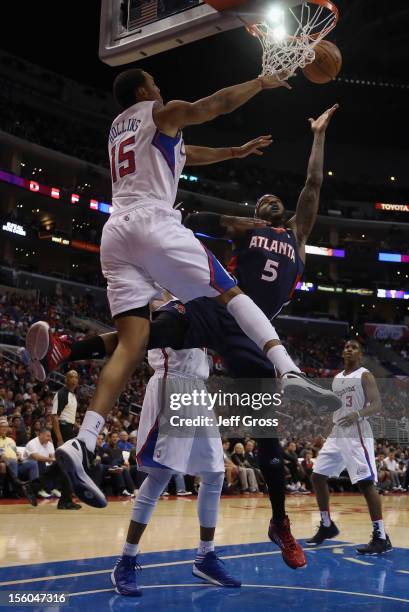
153, 73, 291, 136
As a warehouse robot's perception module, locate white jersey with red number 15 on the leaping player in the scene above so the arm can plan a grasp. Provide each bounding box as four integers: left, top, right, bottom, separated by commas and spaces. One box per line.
108, 101, 186, 212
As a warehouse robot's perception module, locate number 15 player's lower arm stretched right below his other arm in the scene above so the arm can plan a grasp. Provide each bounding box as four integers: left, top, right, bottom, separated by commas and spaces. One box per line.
185, 134, 272, 166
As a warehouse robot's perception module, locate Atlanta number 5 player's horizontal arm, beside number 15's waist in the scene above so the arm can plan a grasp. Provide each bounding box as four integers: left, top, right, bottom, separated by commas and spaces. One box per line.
183, 213, 270, 239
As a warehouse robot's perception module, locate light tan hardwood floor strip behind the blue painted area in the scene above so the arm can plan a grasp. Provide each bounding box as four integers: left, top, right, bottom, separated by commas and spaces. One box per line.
0, 494, 409, 568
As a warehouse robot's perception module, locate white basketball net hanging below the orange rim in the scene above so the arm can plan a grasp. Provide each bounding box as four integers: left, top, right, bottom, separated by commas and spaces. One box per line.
247, 2, 338, 78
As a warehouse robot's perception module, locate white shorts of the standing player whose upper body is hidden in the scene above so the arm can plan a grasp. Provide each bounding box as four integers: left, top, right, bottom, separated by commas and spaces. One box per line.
136, 373, 224, 475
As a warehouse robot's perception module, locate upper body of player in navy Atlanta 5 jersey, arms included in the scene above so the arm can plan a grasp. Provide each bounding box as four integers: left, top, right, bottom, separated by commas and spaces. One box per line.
185, 104, 338, 319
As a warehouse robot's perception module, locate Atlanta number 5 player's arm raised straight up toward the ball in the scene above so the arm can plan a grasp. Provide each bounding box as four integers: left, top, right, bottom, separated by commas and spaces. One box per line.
291, 104, 338, 245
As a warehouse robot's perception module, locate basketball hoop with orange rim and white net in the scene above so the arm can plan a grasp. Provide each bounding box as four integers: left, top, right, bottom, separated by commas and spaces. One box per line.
206, 0, 338, 78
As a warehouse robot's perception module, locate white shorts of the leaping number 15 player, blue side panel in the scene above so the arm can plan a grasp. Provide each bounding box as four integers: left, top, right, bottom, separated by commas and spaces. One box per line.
101, 205, 236, 317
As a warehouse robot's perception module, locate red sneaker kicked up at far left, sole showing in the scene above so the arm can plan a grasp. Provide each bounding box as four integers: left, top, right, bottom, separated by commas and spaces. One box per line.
26, 321, 71, 382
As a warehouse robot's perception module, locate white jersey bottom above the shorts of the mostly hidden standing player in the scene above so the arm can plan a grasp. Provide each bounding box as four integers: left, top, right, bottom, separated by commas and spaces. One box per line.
148, 348, 209, 380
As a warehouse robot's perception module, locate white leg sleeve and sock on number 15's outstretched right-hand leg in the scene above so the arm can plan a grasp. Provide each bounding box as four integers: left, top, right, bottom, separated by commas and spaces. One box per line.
227, 293, 300, 374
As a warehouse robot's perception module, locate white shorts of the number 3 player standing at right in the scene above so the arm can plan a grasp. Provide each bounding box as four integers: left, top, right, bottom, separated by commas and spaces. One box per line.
314, 421, 378, 484
